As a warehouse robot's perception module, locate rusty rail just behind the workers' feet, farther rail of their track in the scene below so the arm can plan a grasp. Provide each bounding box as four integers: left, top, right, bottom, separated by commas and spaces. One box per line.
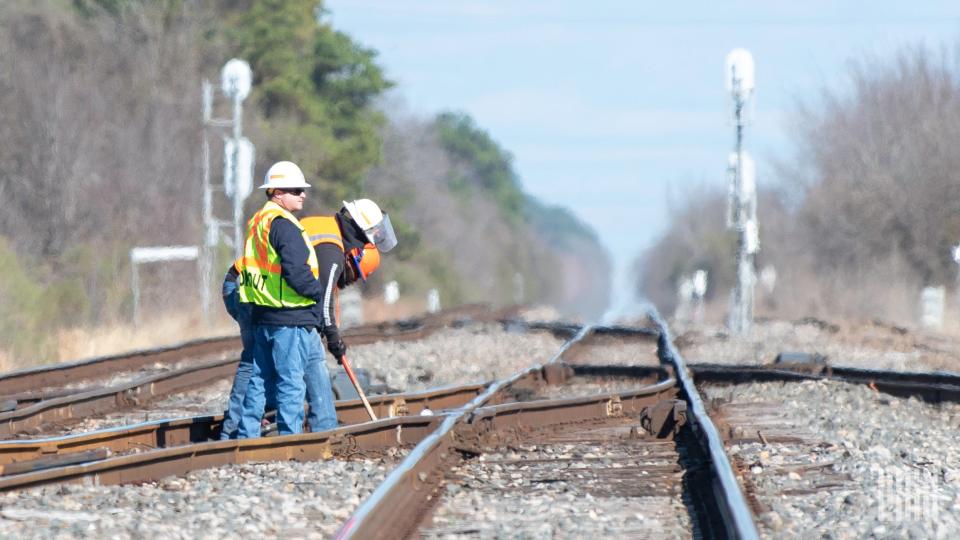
0, 384, 486, 465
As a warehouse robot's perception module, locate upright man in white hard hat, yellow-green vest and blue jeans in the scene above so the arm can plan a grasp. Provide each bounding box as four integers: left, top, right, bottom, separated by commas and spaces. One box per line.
237, 161, 324, 438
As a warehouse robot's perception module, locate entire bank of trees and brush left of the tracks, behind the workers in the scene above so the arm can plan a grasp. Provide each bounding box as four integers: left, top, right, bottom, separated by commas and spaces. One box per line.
0, 0, 609, 368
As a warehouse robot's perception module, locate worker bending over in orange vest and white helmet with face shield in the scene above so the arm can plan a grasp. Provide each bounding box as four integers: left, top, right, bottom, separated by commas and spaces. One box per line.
301, 199, 396, 432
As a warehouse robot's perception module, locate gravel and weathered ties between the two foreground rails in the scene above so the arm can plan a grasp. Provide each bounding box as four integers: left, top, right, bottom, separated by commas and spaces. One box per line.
417, 417, 711, 538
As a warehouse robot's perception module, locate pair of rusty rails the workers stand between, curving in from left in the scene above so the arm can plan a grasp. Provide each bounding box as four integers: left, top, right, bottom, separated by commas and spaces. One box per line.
0, 324, 672, 490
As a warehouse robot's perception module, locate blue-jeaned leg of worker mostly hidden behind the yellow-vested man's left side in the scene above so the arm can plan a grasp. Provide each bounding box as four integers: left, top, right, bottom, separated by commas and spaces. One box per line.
220, 280, 276, 440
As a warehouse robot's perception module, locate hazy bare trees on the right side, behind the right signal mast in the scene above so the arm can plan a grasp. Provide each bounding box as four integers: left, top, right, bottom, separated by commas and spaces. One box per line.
637, 44, 960, 322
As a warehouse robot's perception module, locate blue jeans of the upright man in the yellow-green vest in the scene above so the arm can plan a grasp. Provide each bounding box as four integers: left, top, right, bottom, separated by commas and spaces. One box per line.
237, 325, 314, 439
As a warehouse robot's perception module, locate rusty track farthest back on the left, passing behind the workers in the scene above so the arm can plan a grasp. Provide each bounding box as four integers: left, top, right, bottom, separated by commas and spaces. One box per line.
0, 305, 520, 439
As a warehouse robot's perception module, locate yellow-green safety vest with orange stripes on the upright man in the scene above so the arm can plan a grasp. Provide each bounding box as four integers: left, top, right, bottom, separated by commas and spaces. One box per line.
237, 201, 320, 308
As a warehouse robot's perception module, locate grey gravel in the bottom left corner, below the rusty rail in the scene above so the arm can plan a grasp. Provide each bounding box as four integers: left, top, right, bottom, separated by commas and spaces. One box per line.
0, 450, 406, 539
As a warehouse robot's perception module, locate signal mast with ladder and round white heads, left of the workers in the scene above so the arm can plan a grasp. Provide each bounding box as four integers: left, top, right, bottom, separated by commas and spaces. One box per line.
200, 58, 254, 322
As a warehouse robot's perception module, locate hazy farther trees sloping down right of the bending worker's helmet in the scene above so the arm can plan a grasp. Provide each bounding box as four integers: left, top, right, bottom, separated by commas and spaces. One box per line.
368, 113, 610, 317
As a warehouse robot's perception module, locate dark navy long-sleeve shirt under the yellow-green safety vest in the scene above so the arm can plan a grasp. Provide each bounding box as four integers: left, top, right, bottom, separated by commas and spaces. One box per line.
253, 217, 324, 326
